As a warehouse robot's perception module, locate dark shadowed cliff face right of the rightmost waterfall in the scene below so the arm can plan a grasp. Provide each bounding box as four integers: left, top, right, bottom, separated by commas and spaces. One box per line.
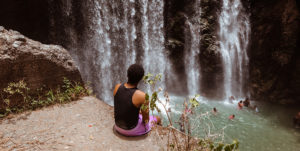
249, 0, 300, 103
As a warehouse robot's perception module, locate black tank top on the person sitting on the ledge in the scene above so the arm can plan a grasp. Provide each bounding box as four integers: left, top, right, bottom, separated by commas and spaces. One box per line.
114, 84, 140, 130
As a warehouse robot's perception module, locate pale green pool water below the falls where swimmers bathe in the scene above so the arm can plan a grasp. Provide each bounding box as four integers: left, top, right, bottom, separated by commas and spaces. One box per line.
162, 96, 300, 151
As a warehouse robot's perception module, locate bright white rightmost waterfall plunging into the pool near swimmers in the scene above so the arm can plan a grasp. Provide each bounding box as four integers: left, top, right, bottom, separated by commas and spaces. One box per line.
219, 0, 250, 98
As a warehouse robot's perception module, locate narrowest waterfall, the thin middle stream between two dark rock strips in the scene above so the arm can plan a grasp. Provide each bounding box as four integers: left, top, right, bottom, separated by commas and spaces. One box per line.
184, 0, 201, 95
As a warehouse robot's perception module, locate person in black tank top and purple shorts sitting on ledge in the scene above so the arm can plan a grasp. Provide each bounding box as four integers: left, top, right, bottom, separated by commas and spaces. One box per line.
113, 64, 161, 136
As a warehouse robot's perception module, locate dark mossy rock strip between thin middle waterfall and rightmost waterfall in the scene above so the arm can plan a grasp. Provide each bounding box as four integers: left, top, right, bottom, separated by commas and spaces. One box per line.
200, 0, 224, 98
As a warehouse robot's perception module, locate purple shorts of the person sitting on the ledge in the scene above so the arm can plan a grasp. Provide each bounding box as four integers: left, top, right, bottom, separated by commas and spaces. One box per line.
114, 114, 157, 136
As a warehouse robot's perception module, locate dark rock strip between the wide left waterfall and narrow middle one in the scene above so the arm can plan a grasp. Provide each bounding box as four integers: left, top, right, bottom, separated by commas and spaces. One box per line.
164, 0, 195, 94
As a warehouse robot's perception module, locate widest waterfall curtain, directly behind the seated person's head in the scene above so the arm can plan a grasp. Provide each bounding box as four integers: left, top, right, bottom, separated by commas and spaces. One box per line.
52, 0, 166, 104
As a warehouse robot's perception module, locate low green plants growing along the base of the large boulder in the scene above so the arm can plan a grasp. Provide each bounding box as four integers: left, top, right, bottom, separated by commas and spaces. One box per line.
0, 78, 91, 118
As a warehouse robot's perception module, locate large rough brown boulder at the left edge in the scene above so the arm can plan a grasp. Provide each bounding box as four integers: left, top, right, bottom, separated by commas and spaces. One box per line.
0, 26, 82, 99
